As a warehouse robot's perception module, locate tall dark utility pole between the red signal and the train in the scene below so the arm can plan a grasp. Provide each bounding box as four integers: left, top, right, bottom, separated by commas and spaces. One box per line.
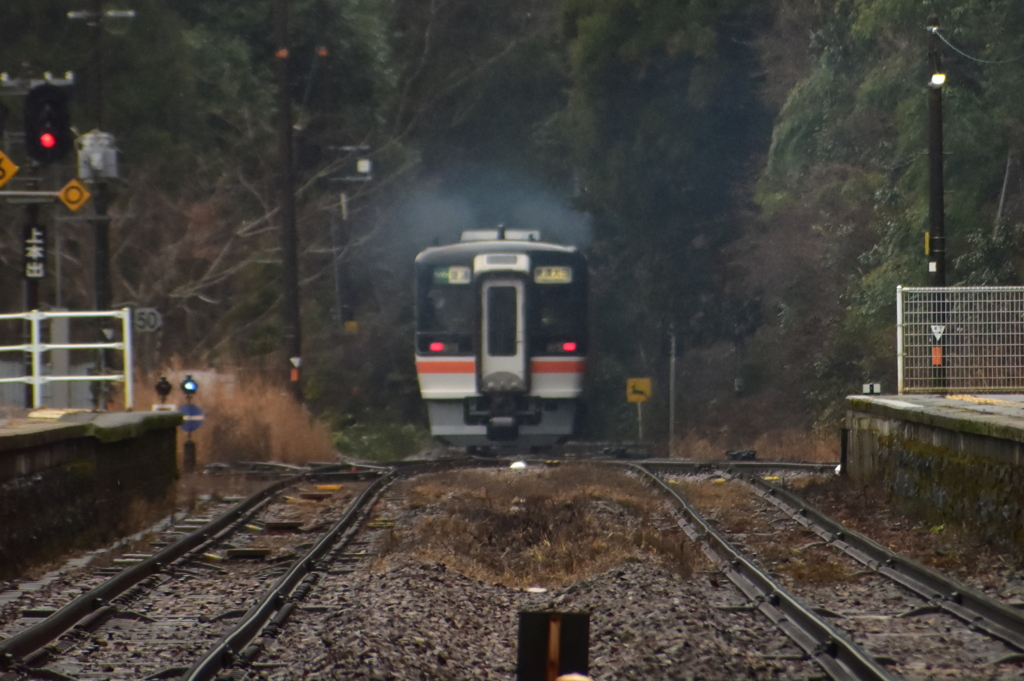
274, 0, 302, 402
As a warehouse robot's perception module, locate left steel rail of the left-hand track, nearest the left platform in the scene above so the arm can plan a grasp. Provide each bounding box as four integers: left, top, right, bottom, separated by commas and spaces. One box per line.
0, 474, 305, 669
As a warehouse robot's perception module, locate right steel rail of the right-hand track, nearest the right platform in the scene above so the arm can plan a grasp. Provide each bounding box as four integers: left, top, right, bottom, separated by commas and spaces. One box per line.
738, 475, 1024, 651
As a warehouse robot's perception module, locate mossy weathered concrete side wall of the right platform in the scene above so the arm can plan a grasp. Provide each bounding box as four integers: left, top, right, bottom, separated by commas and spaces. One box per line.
847, 397, 1024, 549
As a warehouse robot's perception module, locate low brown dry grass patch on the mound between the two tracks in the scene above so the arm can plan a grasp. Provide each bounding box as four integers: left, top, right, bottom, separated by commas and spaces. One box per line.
382, 466, 696, 587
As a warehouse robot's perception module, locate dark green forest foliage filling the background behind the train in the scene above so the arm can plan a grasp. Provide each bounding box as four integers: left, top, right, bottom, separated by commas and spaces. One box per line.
0, 0, 1024, 446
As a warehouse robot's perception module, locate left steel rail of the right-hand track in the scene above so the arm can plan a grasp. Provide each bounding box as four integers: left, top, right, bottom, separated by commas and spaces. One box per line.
620, 464, 895, 681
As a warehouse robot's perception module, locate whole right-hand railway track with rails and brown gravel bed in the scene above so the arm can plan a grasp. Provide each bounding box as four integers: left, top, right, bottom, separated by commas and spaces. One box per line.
643, 464, 1024, 679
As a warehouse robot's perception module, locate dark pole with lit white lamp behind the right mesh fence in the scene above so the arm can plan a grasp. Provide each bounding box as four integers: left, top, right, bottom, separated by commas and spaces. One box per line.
927, 14, 946, 287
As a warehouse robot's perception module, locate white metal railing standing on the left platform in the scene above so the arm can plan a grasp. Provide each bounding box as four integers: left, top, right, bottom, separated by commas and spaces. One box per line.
0, 307, 134, 410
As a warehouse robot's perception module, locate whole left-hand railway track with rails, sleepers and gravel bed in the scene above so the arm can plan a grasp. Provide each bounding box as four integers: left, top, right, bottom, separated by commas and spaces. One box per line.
0, 463, 478, 681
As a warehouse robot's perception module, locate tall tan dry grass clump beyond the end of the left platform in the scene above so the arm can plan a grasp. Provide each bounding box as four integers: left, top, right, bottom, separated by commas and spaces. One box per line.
135, 365, 336, 468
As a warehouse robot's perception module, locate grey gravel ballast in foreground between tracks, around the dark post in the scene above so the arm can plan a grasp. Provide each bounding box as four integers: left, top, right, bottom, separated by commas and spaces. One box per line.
263, 561, 816, 680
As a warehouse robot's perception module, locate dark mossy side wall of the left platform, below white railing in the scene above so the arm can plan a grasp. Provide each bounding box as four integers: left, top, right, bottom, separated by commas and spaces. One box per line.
0, 414, 180, 577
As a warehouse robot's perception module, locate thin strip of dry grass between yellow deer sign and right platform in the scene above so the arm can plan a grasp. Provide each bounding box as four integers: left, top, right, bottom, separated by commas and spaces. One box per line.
672, 428, 840, 463
